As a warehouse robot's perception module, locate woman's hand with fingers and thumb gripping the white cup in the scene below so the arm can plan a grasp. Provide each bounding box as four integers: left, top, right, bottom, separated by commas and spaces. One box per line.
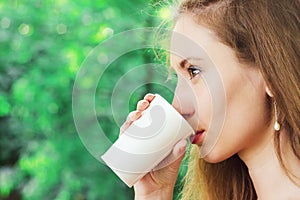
120, 94, 187, 200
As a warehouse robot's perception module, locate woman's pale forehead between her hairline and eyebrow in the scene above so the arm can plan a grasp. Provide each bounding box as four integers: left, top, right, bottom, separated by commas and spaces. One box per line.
170, 15, 219, 62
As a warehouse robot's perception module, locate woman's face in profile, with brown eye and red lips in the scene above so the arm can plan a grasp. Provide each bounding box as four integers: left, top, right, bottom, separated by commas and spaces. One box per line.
171, 15, 272, 163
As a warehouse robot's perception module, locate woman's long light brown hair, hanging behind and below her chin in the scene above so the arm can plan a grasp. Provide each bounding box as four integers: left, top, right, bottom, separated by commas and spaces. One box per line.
179, 0, 300, 200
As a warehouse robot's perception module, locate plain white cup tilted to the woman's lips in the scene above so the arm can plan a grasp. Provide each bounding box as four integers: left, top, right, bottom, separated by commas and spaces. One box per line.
101, 94, 194, 187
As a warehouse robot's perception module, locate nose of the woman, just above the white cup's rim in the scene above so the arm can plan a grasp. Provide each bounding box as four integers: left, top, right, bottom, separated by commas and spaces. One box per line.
172, 79, 195, 119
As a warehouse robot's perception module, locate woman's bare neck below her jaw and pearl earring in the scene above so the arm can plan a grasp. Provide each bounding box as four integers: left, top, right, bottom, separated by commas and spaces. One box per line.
239, 131, 300, 200
